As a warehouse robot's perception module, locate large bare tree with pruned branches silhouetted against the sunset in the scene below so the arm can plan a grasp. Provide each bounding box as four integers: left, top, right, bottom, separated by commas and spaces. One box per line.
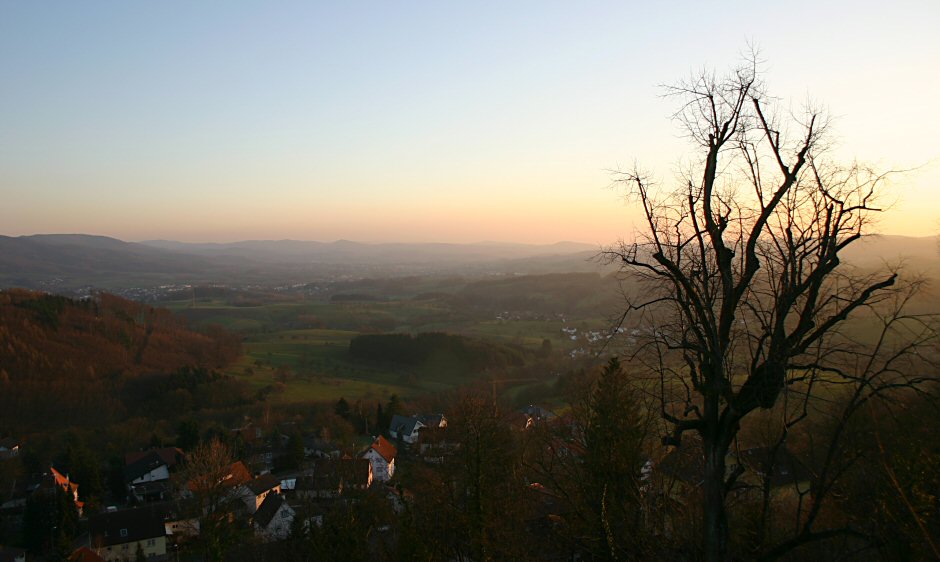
605, 57, 929, 561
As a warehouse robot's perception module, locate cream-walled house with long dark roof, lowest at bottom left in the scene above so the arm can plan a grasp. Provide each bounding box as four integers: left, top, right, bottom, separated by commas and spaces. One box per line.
88, 506, 166, 562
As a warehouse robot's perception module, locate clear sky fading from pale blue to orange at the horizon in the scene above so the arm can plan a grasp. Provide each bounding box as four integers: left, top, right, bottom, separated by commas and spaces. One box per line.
0, 0, 940, 244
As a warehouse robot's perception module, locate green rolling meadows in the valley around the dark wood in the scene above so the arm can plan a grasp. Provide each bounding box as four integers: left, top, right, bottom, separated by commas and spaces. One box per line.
162, 274, 608, 403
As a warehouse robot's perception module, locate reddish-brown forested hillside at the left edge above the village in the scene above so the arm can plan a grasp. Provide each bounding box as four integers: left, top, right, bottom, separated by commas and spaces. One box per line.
0, 289, 241, 427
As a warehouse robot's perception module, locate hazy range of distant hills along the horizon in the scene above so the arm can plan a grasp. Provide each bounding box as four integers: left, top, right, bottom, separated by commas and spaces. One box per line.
0, 234, 940, 293
